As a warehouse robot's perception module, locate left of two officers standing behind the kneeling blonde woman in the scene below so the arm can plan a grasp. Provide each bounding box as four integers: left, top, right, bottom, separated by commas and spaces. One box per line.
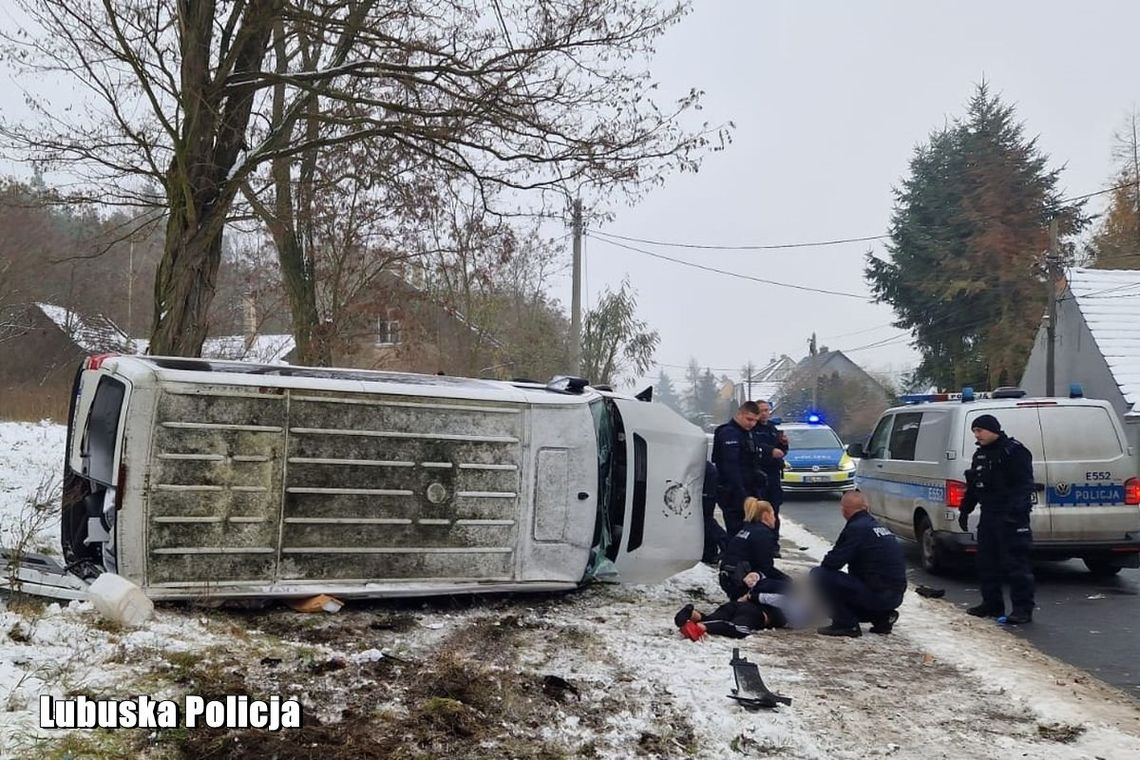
713, 401, 764, 536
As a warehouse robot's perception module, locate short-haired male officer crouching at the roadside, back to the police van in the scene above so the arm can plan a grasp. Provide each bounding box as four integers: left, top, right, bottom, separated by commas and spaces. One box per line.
811, 490, 906, 638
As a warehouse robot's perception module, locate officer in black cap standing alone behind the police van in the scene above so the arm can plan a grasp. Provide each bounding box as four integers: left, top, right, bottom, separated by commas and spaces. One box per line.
958, 415, 1034, 624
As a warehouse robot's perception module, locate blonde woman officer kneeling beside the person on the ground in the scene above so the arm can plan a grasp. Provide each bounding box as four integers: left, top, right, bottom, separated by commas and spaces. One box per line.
717, 497, 791, 600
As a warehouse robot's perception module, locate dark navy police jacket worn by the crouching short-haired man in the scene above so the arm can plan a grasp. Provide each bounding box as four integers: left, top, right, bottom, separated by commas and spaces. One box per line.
820, 509, 906, 599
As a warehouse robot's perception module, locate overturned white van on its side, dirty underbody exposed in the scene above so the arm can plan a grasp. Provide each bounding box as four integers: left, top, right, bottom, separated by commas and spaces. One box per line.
6, 356, 706, 599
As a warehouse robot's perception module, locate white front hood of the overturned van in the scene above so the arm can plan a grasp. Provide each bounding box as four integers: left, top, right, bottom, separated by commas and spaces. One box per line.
612, 397, 708, 583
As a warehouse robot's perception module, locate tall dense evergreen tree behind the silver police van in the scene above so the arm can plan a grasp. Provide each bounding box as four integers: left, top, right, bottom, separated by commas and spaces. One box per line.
866, 83, 1088, 387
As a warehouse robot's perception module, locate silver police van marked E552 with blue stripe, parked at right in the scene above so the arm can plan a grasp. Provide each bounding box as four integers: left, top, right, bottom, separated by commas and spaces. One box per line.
847, 386, 1140, 575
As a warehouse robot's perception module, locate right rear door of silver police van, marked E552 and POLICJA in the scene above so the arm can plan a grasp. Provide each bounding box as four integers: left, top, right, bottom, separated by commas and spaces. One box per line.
1039, 404, 1140, 541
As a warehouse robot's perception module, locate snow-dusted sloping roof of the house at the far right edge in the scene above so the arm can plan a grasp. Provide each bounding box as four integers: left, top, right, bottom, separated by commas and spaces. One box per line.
1067, 268, 1140, 408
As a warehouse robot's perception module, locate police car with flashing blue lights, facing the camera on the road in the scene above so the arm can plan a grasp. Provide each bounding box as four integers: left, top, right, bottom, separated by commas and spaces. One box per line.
779, 415, 855, 492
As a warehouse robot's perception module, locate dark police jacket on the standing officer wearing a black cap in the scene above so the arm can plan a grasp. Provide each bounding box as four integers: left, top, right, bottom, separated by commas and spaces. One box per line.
961, 433, 1034, 514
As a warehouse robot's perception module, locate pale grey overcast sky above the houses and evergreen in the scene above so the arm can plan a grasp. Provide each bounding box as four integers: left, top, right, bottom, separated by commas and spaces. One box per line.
562, 0, 1140, 391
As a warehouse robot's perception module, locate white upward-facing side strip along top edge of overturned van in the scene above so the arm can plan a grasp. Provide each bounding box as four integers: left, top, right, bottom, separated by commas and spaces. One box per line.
101, 356, 601, 404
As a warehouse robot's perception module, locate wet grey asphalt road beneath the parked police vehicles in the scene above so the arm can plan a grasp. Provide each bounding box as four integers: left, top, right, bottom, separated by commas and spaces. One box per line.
780, 495, 1140, 700
